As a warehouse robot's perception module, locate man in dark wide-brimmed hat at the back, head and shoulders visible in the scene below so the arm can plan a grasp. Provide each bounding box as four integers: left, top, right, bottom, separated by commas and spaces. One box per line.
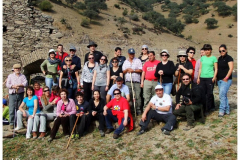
84, 41, 103, 64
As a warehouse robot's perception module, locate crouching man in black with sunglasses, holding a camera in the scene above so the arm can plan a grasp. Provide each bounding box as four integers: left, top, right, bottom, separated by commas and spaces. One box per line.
173, 73, 204, 131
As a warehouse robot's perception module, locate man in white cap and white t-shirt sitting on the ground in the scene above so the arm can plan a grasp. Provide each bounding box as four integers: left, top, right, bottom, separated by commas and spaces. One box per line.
137, 85, 176, 135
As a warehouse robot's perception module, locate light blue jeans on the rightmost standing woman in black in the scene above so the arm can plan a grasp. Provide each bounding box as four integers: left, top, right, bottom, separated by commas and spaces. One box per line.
218, 79, 232, 114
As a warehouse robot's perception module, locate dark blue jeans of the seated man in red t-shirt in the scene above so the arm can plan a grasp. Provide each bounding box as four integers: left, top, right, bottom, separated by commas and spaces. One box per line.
105, 109, 130, 135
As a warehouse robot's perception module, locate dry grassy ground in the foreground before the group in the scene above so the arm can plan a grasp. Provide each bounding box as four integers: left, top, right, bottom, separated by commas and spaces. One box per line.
3, 85, 237, 160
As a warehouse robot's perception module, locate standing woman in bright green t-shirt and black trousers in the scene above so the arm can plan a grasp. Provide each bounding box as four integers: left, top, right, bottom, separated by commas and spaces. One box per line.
197, 44, 218, 115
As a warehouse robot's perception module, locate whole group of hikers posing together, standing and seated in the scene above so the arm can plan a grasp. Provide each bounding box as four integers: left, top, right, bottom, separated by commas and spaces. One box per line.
3, 41, 233, 141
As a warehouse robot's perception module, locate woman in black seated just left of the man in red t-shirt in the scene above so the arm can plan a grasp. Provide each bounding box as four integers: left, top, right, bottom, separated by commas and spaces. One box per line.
87, 90, 105, 137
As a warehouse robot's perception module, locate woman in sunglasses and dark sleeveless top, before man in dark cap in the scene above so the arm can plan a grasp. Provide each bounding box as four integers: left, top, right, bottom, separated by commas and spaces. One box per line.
59, 57, 80, 99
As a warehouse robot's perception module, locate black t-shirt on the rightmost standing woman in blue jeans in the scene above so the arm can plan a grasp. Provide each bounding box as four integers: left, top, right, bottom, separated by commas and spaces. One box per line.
217, 54, 233, 80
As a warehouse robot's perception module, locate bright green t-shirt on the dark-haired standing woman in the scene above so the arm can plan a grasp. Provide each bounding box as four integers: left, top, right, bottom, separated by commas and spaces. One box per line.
200, 56, 217, 78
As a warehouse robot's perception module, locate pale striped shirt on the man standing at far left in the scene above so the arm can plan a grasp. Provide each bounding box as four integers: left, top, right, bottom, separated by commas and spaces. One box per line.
6, 73, 27, 94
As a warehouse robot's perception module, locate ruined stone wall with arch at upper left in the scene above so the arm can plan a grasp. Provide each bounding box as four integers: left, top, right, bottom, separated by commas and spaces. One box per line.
3, 0, 63, 80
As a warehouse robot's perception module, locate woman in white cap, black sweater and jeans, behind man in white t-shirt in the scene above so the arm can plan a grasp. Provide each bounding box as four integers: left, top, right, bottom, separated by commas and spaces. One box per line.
155, 49, 175, 95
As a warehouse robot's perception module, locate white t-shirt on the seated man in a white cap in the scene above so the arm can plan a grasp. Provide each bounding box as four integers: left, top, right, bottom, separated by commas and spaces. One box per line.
150, 93, 172, 114
